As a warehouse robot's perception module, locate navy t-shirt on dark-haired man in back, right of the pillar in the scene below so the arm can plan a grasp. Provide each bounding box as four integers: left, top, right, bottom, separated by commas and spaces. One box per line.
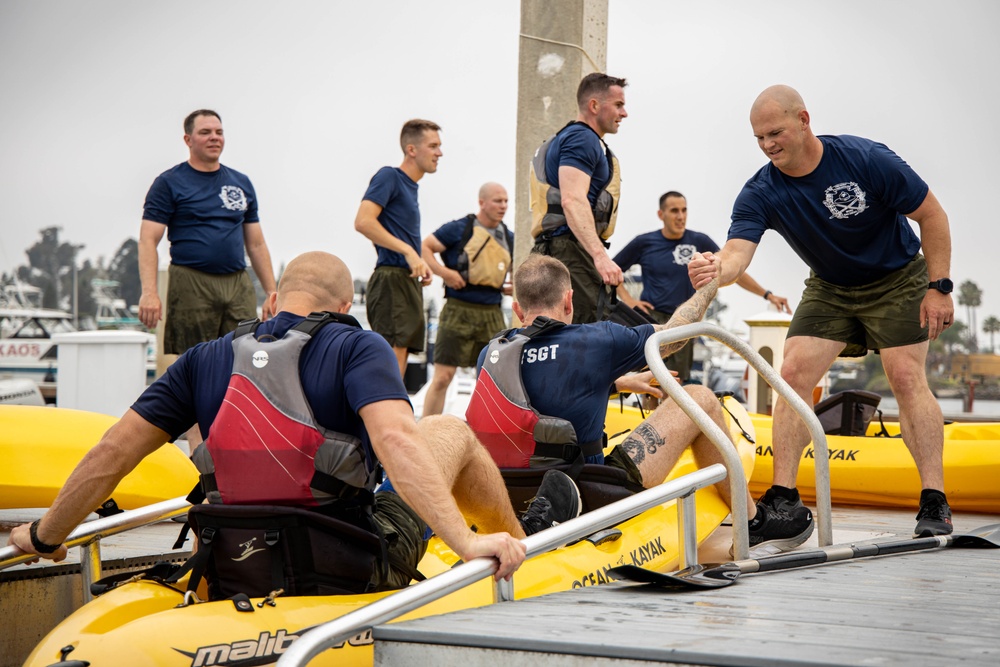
614, 229, 719, 315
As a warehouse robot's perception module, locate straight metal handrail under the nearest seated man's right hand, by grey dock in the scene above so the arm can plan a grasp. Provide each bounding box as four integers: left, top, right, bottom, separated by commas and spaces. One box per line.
277, 463, 726, 667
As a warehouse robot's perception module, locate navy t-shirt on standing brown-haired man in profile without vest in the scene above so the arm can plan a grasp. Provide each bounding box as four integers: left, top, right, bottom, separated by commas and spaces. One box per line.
362, 167, 420, 269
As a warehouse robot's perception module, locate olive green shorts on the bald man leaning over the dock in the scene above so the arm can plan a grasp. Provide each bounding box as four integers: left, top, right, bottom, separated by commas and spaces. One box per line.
788, 254, 928, 357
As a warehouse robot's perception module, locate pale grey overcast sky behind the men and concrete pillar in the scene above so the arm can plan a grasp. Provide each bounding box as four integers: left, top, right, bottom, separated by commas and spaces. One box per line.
0, 0, 1000, 340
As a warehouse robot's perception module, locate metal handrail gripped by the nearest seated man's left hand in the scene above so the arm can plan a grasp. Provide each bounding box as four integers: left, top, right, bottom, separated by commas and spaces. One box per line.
0, 496, 191, 602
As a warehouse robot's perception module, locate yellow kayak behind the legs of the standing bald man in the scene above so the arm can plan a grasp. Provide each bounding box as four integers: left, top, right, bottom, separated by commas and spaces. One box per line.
750, 414, 1000, 513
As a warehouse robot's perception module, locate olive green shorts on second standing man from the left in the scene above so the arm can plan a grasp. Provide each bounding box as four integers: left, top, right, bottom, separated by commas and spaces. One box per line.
367, 266, 426, 352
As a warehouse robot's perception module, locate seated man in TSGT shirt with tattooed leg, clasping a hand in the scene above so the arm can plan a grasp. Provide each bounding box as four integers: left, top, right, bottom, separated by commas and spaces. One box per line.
466, 254, 813, 555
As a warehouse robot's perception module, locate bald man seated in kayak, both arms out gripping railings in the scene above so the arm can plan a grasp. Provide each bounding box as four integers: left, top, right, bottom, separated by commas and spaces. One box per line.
9, 252, 580, 589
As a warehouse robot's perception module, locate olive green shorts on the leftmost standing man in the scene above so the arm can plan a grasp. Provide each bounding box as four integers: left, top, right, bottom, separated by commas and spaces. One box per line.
163, 264, 257, 354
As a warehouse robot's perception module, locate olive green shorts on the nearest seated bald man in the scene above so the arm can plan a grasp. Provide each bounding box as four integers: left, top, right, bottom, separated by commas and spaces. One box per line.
374, 491, 427, 591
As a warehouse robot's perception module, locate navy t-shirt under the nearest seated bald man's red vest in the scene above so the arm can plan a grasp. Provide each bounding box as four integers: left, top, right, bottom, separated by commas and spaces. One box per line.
132, 312, 409, 460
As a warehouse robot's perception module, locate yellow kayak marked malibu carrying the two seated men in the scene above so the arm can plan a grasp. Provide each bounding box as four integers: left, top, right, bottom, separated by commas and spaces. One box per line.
25, 404, 754, 667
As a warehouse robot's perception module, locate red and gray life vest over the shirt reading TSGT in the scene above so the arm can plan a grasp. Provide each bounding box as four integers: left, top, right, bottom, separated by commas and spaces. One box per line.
465, 317, 604, 468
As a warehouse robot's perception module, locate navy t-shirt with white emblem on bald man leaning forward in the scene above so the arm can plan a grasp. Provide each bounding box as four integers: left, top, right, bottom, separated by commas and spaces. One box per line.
729, 135, 928, 286
